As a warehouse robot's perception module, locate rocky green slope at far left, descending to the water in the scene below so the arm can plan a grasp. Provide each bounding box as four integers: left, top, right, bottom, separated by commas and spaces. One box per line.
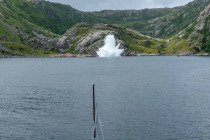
0, 2, 57, 56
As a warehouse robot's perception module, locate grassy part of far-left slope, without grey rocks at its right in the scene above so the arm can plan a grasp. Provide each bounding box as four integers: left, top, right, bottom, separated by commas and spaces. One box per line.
0, 2, 57, 56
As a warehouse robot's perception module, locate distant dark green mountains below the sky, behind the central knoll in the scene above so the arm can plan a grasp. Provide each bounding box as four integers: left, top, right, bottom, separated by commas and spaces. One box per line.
4, 0, 210, 38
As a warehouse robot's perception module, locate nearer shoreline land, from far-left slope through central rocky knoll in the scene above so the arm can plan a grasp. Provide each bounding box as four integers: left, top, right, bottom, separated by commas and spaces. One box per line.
0, 1, 160, 56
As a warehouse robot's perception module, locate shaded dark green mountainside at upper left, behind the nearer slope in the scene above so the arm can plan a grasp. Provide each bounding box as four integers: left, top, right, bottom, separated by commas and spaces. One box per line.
4, 0, 101, 35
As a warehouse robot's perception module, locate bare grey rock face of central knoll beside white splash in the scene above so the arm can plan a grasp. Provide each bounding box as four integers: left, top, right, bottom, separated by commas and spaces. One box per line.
56, 24, 125, 56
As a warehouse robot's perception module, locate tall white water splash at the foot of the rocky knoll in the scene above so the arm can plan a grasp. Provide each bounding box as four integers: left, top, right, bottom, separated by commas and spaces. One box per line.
96, 34, 124, 57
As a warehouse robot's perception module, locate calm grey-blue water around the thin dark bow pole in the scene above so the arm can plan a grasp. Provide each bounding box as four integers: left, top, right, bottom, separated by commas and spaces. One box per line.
0, 56, 210, 140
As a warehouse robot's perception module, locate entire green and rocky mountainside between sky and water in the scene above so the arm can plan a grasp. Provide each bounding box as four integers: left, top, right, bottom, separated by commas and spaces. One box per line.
0, 0, 210, 56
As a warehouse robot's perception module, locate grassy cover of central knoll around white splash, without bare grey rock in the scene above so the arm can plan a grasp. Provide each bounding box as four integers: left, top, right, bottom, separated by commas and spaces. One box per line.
61, 24, 161, 54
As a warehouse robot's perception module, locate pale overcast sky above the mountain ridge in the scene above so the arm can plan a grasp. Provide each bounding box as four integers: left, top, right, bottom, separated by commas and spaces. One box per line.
47, 0, 193, 11
